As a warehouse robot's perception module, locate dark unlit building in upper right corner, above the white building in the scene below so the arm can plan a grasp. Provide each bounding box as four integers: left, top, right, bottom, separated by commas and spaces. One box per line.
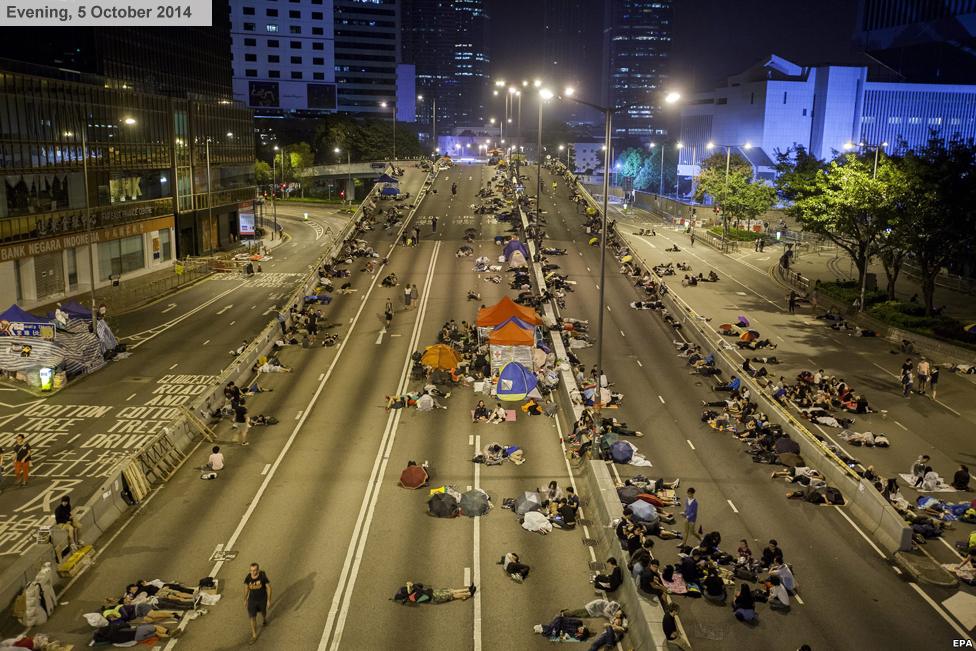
855, 0, 976, 84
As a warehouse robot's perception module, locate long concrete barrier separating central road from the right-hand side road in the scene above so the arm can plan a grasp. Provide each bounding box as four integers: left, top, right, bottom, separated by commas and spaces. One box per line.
618, 211, 912, 554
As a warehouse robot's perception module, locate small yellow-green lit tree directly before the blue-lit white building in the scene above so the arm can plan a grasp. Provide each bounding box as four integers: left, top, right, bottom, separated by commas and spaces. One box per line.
695, 159, 776, 238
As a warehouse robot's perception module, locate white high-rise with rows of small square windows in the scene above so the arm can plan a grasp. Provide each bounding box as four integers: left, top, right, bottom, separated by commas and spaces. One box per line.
230, 0, 337, 116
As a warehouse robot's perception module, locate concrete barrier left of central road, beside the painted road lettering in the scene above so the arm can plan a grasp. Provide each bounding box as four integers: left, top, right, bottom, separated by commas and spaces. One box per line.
0, 176, 408, 620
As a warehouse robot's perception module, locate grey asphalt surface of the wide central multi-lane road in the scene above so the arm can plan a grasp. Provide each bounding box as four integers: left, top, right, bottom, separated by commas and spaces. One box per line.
11, 165, 966, 649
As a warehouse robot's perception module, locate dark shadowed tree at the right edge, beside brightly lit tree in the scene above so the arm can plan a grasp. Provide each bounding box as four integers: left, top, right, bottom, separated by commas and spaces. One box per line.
896, 137, 976, 315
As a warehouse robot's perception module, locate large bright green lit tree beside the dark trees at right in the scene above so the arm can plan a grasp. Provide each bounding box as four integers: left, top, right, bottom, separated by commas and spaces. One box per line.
792, 154, 896, 308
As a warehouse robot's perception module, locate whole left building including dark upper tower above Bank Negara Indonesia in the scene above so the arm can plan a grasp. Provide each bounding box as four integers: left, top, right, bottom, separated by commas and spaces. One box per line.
0, 14, 255, 306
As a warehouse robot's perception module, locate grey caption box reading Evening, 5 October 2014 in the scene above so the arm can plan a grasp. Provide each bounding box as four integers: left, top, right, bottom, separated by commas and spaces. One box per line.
0, 0, 213, 27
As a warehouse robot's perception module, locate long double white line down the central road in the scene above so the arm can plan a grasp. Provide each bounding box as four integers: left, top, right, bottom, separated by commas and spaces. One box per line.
318, 241, 442, 651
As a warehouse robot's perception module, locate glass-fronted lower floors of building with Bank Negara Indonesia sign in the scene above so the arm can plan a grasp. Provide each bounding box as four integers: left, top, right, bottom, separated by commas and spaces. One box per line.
0, 62, 255, 307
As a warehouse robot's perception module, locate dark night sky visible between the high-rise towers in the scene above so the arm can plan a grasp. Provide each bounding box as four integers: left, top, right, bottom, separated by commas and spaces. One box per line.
488, 0, 857, 103
